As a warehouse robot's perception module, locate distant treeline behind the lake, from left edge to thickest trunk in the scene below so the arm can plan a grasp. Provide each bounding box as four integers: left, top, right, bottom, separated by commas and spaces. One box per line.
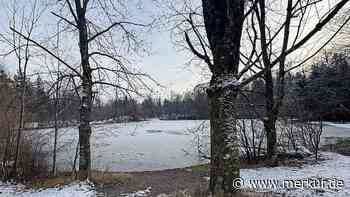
0, 71, 208, 124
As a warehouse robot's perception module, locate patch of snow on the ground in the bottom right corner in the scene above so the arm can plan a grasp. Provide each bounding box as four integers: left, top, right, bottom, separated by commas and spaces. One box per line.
241, 152, 350, 197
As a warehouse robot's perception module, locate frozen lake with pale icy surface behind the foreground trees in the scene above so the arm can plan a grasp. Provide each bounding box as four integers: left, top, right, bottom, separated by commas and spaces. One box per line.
36, 120, 350, 171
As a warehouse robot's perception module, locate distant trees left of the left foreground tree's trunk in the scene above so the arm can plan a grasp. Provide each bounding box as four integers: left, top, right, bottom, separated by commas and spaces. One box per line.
0, 70, 79, 125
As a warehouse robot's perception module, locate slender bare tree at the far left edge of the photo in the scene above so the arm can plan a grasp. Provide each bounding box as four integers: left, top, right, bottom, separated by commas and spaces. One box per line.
0, 0, 41, 178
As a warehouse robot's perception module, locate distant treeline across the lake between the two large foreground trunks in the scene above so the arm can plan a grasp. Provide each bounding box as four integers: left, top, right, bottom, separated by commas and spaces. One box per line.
93, 91, 209, 121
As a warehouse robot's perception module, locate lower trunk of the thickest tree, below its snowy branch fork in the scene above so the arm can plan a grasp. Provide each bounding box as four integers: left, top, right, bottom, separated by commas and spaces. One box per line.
208, 75, 240, 196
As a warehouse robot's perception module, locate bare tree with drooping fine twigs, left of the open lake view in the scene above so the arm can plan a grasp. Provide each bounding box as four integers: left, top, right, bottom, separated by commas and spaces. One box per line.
11, 0, 154, 179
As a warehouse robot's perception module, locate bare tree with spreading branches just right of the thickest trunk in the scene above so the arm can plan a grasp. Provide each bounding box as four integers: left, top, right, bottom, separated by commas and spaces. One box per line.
245, 0, 350, 158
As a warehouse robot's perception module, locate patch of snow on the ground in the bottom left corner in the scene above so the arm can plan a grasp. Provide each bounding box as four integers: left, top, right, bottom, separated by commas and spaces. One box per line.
0, 182, 97, 197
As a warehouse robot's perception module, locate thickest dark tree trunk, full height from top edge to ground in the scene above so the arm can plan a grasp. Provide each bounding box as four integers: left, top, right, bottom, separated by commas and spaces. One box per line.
198, 0, 245, 196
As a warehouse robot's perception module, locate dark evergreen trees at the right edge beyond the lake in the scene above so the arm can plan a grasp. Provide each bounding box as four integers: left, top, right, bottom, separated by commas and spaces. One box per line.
285, 52, 350, 121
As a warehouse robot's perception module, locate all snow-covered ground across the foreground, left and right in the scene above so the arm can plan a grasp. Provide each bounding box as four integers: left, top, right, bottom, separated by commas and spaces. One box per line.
0, 152, 350, 197
